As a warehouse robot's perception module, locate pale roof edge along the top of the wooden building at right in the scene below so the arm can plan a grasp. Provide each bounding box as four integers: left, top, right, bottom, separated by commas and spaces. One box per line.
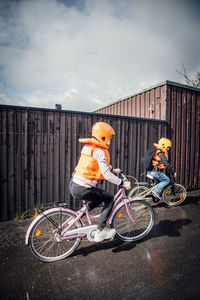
94, 80, 200, 112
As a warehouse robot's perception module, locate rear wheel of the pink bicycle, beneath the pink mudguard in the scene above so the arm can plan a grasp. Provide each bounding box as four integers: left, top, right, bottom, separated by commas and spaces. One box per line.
29, 208, 82, 262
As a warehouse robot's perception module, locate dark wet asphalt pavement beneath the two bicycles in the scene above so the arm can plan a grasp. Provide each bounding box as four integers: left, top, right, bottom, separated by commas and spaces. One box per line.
0, 194, 200, 300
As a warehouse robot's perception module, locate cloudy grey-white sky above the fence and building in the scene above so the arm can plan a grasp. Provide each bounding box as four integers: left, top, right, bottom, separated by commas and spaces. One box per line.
0, 0, 200, 111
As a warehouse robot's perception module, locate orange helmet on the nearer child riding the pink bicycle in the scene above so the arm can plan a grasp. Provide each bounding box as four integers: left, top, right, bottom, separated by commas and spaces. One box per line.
92, 122, 115, 148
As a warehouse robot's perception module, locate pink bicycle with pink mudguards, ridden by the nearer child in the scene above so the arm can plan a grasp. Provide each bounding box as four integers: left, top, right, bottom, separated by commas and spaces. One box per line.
25, 174, 155, 262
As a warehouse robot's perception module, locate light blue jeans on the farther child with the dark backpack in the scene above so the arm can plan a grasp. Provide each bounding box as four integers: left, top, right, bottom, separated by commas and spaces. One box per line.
147, 171, 170, 195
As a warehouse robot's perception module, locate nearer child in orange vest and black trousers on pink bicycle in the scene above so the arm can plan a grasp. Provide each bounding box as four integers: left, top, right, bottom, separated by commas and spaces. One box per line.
70, 122, 131, 242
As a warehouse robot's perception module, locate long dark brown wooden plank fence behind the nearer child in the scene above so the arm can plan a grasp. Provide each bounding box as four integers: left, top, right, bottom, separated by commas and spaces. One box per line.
0, 105, 168, 221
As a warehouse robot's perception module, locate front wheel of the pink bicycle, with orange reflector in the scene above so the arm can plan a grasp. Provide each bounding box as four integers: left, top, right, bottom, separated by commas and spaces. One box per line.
111, 200, 155, 242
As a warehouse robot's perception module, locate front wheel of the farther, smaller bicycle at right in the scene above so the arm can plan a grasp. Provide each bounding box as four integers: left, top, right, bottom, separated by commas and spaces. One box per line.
162, 183, 187, 206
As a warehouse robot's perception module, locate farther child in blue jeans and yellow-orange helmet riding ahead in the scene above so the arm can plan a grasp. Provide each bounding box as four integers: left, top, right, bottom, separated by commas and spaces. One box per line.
147, 138, 174, 199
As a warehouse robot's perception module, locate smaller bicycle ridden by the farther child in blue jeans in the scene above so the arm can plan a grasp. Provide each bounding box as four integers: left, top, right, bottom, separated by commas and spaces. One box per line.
128, 174, 187, 206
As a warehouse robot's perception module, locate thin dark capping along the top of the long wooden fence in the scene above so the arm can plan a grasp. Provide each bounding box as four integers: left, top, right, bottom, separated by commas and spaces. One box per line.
0, 104, 168, 123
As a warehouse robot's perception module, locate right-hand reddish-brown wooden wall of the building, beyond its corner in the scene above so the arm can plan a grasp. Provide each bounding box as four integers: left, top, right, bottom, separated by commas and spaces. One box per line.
166, 84, 200, 189
